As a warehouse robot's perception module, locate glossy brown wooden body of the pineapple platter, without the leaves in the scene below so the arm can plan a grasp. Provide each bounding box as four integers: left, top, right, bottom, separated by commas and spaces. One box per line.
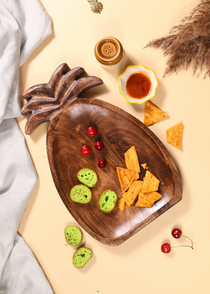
47, 98, 182, 245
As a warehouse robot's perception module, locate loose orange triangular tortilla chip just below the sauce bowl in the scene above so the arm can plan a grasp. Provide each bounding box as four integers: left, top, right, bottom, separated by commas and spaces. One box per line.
144, 101, 169, 126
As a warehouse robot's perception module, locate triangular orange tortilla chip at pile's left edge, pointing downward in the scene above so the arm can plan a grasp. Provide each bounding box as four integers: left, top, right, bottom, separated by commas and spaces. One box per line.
117, 167, 139, 192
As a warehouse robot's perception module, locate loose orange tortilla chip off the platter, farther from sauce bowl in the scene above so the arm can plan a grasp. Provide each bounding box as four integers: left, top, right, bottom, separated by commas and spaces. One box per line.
166, 123, 184, 150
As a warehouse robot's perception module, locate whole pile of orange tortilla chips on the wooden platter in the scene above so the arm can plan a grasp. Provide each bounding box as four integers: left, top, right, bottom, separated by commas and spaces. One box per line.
117, 146, 162, 210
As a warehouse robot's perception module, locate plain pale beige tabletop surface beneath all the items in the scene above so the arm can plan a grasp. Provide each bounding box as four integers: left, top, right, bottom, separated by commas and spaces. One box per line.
18, 0, 210, 294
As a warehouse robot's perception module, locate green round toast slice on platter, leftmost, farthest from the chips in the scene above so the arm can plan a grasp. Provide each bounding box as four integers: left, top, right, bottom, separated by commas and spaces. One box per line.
70, 185, 92, 203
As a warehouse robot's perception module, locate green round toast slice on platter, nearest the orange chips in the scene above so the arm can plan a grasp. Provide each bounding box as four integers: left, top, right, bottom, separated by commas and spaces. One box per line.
98, 190, 117, 213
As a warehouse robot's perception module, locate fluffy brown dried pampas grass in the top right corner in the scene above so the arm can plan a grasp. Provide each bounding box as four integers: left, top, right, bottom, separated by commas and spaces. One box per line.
145, 0, 210, 78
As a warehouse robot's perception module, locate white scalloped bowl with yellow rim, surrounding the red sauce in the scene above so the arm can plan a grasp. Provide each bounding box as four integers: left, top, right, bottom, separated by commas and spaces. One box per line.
118, 64, 159, 104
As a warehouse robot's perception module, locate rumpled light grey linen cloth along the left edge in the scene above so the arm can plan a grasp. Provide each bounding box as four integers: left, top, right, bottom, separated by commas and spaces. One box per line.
0, 0, 53, 294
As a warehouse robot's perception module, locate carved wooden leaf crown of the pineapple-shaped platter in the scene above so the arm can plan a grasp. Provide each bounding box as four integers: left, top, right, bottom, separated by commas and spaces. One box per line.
21, 63, 103, 134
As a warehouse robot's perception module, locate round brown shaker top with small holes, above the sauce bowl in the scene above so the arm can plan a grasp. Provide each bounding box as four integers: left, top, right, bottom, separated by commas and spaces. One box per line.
94, 37, 123, 65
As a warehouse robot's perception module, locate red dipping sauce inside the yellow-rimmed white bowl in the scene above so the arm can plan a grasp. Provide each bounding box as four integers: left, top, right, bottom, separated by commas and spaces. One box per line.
126, 72, 152, 99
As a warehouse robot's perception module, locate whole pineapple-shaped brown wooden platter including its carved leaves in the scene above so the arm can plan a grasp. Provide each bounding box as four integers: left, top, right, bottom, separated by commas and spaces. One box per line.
22, 63, 182, 245
